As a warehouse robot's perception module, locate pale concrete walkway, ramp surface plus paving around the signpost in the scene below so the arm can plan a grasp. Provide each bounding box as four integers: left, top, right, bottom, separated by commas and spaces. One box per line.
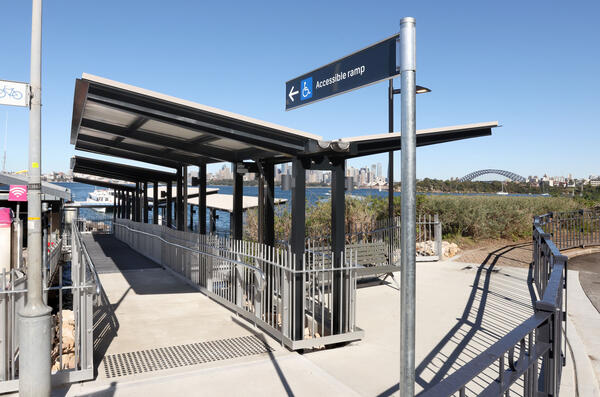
41, 236, 580, 397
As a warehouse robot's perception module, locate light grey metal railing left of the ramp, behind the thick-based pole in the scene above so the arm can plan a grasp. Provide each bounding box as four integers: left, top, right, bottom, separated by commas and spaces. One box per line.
0, 223, 99, 393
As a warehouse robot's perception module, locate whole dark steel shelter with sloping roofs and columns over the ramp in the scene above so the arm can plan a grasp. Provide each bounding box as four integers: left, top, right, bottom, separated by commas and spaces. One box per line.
71, 74, 498, 342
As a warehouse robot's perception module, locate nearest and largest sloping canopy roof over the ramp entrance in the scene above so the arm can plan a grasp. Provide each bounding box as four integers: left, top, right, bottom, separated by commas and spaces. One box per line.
71, 74, 322, 167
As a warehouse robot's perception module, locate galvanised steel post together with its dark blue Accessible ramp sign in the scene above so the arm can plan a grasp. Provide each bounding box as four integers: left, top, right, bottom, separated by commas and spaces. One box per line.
285, 23, 416, 397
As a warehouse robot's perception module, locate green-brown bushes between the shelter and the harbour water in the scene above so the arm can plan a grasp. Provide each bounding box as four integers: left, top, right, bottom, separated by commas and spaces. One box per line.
245, 195, 592, 241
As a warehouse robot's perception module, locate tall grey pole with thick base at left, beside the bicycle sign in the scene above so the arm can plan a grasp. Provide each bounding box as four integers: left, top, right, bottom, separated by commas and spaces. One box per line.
19, 0, 50, 397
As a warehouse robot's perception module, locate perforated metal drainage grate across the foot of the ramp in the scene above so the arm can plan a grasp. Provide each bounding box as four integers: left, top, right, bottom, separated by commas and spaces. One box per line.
103, 336, 273, 378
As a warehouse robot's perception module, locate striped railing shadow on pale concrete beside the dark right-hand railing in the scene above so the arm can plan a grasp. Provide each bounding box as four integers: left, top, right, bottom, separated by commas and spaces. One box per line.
379, 244, 535, 397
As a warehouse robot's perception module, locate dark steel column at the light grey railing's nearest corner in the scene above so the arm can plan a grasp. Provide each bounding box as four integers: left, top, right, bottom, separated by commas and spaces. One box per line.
290, 159, 306, 340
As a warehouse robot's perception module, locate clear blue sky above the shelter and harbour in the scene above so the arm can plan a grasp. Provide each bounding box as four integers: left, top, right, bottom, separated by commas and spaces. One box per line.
0, 0, 600, 178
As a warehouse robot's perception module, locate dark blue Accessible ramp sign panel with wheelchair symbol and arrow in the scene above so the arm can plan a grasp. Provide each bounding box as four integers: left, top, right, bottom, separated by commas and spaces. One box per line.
285, 34, 400, 110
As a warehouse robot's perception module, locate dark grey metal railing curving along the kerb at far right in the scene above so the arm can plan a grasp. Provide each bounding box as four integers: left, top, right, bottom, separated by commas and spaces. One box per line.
421, 210, 600, 397
